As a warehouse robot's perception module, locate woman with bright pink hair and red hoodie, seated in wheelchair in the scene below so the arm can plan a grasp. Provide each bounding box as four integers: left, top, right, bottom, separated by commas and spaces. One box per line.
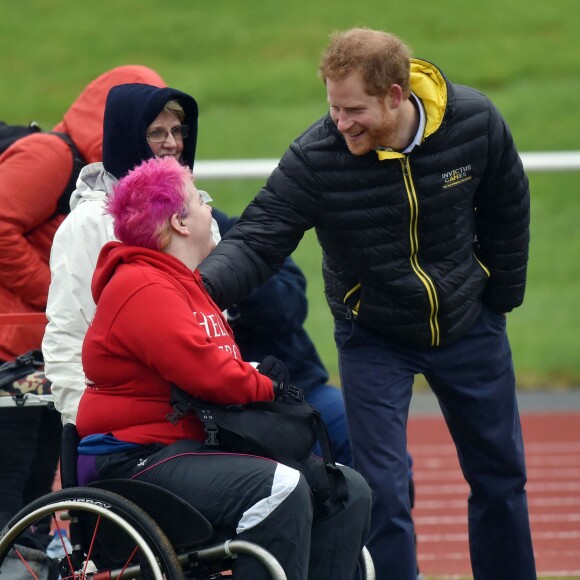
77, 157, 371, 580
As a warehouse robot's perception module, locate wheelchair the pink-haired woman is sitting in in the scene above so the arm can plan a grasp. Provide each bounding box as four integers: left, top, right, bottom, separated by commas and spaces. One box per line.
0, 424, 375, 580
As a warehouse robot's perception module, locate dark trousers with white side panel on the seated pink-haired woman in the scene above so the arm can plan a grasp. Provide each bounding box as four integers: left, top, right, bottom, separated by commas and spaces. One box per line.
94, 440, 372, 580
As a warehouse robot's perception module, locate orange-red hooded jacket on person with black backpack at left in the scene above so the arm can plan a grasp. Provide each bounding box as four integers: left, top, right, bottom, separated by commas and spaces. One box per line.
0, 65, 165, 360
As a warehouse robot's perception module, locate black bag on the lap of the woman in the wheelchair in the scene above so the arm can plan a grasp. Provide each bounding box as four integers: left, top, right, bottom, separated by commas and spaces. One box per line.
167, 385, 347, 500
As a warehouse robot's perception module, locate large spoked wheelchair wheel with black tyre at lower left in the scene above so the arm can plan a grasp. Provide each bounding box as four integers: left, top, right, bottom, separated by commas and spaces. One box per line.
0, 487, 184, 580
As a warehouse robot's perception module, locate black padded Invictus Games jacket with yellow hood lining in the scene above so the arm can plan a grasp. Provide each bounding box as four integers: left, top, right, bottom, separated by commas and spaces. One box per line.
201, 59, 529, 347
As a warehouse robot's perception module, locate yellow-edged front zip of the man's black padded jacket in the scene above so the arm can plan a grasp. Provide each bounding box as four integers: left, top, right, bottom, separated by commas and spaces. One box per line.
399, 157, 441, 346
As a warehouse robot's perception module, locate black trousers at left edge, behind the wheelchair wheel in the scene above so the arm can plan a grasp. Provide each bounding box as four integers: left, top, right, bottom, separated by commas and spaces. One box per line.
0, 407, 62, 528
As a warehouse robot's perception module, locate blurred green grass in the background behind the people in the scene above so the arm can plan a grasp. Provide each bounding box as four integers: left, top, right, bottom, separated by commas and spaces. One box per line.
0, 0, 580, 388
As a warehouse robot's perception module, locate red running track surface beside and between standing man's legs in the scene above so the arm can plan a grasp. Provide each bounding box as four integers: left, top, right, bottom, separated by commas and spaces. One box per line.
409, 412, 580, 578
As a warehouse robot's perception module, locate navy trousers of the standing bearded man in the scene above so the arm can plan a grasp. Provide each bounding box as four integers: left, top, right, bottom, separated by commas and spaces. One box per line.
335, 309, 536, 580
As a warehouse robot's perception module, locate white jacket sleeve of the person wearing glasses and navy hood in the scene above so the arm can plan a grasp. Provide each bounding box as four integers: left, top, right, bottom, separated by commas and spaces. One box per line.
42, 193, 115, 423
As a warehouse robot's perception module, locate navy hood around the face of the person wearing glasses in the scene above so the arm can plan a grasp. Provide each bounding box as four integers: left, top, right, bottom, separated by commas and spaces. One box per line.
103, 83, 198, 179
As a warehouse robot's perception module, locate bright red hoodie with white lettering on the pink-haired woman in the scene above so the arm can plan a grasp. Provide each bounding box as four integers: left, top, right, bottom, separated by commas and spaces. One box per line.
77, 242, 273, 444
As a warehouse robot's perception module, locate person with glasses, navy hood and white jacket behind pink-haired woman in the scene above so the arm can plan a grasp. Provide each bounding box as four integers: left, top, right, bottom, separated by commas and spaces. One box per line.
42, 84, 202, 423
